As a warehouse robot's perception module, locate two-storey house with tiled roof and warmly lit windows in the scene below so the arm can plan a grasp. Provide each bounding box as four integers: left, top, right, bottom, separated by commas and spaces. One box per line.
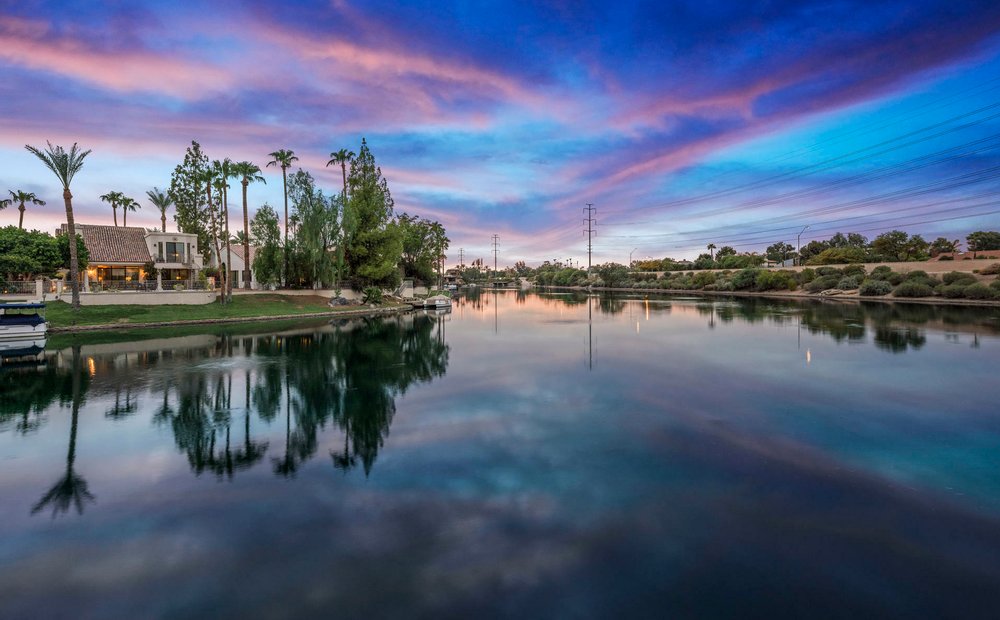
56, 224, 203, 288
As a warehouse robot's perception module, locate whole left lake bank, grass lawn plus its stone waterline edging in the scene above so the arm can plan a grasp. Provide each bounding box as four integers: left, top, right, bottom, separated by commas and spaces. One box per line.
45, 293, 410, 332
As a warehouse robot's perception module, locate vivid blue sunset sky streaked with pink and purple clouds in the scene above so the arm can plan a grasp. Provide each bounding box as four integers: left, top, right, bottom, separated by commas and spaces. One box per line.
0, 0, 1000, 266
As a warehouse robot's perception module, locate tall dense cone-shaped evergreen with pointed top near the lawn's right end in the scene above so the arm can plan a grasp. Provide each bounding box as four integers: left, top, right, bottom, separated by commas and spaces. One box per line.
346, 138, 403, 288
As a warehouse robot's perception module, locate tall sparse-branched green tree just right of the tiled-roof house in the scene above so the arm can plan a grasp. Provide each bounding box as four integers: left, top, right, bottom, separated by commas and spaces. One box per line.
168, 140, 211, 256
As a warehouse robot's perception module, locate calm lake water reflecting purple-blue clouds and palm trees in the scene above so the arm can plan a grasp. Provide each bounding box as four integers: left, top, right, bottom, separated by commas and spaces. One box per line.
0, 292, 1000, 618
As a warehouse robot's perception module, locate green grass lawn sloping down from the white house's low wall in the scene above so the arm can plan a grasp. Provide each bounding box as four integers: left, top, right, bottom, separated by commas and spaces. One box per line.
45, 295, 357, 327
